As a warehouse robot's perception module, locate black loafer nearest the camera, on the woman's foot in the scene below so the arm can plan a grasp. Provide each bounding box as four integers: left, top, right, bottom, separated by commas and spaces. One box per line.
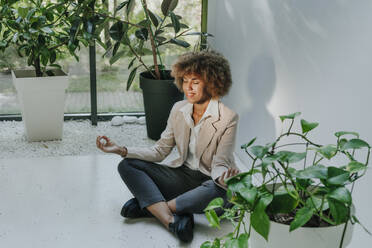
169, 214, 194, 242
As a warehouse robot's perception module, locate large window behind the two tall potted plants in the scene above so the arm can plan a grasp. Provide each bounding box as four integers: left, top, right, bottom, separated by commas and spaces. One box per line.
0, 0, 202, 118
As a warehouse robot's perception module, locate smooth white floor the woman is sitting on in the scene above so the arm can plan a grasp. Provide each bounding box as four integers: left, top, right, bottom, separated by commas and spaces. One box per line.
0, 155, 231, 248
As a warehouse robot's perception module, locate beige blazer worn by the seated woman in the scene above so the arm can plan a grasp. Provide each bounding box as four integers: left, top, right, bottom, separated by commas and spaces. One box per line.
126, 100, 238, 185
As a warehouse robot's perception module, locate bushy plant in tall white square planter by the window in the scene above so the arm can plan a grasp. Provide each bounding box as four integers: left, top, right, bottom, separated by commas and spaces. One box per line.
0, 0, 101, 141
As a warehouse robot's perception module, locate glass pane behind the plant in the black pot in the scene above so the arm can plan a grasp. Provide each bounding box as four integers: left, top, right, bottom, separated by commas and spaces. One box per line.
96, 0, 201, 113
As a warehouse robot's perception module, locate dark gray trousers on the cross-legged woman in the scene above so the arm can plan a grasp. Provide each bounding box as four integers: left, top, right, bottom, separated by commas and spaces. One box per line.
118, 158, 227, 214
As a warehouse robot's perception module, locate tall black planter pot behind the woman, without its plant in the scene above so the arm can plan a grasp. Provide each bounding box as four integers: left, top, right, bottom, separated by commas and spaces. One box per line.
140, 71, 184, 140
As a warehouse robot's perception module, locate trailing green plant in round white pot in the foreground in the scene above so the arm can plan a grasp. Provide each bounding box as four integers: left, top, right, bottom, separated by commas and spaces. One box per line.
201, 113, 371, 248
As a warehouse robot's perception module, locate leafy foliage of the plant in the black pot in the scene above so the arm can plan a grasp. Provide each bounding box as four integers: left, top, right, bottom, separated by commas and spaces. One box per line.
101, 0, 211, 90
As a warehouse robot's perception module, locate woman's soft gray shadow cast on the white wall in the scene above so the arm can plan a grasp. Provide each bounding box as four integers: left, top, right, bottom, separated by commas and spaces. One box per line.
237, 53, 276, 165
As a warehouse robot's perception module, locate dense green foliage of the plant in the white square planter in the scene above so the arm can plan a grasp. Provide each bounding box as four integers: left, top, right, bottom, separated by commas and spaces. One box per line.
0, 0, 104, 77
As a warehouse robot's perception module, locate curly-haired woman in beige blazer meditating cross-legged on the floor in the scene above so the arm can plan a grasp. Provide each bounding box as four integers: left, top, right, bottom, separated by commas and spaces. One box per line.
96, 51, 239, 242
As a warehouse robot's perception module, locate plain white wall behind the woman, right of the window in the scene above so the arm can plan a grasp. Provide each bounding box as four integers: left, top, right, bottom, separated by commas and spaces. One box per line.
208, 0, 372, 248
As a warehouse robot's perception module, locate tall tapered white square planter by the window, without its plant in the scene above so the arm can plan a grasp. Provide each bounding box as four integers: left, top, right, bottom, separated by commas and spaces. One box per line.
12, 70, 68, 141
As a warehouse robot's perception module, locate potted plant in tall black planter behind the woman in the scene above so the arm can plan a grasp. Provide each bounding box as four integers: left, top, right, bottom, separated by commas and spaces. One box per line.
105, 0, 210, 140
